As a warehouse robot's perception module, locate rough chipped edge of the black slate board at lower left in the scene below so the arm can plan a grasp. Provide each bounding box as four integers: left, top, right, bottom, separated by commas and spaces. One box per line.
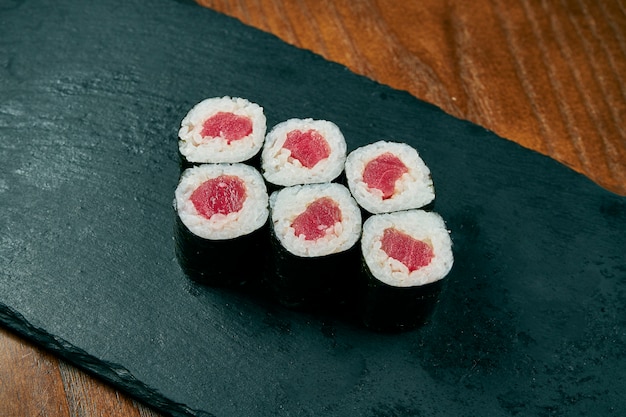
0, 303, 205, 417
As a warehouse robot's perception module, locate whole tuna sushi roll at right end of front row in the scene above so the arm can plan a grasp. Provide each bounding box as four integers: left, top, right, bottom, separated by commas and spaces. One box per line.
361, 210, 453, 331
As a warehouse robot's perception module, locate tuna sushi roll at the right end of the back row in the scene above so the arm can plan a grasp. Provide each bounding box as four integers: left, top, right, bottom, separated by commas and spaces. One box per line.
345, 141, 435, 214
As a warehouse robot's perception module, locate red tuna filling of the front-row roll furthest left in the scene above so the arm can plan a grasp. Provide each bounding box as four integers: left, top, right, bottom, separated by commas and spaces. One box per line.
191, 175, 246, 219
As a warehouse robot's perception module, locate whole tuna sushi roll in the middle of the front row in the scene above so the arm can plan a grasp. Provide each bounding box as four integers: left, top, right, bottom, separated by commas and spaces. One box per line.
267, 183, 361, 308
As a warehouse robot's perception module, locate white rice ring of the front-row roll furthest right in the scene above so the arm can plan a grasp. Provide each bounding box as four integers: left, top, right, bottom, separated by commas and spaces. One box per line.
361, 210, 454, 287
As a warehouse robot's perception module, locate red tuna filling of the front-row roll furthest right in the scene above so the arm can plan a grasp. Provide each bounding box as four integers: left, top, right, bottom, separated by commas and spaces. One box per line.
381, 228, 435, 272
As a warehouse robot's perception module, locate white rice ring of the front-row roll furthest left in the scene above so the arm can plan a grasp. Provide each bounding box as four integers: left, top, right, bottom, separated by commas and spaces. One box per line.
174, 164, 269, 240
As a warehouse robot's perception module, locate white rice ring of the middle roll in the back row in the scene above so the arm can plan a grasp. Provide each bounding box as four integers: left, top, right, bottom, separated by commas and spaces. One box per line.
261, 119, 347, 187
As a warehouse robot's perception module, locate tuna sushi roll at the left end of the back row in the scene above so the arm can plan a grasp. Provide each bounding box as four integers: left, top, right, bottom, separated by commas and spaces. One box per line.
178, 97, 266, 164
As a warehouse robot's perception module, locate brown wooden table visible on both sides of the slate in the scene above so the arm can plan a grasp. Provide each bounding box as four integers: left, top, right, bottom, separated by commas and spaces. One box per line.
0, 0, 626, 417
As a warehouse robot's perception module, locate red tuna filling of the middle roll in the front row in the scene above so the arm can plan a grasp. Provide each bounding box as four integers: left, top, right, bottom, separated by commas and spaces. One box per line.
291, 197, 341, 240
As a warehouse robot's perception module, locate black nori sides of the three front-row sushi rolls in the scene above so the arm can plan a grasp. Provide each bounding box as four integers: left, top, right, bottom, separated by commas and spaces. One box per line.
174, 216, 442, 333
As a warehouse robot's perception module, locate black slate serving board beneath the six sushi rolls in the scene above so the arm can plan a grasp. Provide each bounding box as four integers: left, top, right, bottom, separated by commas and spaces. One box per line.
0, 0, 626, 416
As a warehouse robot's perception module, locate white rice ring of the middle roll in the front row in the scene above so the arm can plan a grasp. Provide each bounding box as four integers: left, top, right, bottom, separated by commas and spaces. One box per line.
270, 183, 361, 257
